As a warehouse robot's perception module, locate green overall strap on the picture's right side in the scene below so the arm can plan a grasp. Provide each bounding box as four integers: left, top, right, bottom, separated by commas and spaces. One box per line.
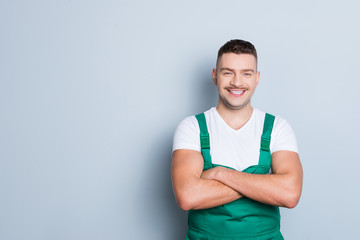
259, 113, 275, 167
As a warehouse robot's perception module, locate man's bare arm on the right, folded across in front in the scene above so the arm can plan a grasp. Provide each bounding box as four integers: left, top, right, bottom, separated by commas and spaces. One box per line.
205, 151, 303, 208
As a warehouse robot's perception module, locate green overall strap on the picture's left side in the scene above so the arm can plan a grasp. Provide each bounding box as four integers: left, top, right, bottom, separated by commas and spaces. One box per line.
195, 113, 212, 171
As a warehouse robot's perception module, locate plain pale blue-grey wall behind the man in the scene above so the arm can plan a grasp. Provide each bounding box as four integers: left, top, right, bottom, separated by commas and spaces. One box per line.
0, 0, 360, 240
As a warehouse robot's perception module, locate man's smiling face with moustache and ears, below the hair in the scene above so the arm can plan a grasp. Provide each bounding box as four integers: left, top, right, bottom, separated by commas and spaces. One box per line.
213, 53, 260, 110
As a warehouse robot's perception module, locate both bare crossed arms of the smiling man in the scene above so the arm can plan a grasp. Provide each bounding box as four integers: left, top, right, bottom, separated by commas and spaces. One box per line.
171, 149, 303, 211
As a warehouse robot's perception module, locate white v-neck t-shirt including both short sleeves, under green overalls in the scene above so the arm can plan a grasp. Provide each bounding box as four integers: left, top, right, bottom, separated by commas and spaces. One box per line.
173, 107, 298, 171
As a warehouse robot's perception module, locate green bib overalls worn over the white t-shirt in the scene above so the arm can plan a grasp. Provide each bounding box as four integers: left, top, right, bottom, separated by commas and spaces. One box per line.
185, 113, 283, 240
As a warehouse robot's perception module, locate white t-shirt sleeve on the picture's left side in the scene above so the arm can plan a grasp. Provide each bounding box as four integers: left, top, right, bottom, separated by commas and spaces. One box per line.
173, 116, 201, 152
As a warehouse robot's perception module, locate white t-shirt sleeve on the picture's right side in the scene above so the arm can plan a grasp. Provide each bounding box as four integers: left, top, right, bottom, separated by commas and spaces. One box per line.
270, 117, 298, 153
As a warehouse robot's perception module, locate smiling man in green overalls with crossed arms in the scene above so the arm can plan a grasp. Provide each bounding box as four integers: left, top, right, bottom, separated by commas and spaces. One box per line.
172, 40, 302, 239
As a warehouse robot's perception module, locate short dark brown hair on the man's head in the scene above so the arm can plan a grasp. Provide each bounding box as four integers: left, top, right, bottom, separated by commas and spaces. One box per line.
216, 39, 257, 67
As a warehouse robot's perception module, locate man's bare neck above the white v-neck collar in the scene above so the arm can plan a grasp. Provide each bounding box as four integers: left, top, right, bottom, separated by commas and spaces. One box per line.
216, 103, 254, 130
